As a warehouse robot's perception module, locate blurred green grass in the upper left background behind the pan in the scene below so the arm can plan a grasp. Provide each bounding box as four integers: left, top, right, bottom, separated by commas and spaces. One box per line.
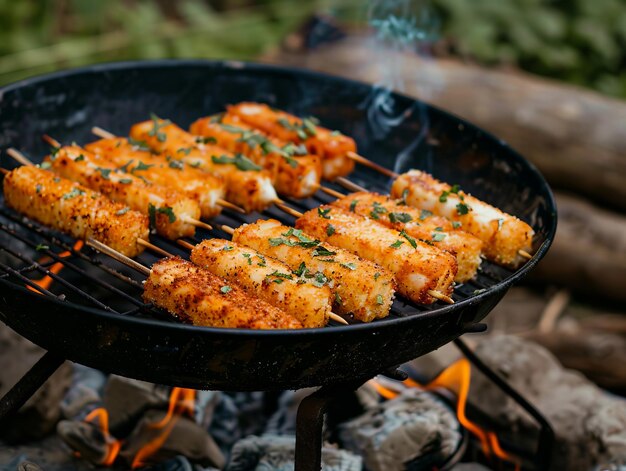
0, 0, 316, 84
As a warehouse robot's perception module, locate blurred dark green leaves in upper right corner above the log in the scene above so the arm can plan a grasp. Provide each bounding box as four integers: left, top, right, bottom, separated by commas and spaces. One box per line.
432, 0, 626, 98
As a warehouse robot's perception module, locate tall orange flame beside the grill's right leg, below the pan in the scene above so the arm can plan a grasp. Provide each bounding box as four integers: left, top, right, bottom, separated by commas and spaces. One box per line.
372, 358, 521, 471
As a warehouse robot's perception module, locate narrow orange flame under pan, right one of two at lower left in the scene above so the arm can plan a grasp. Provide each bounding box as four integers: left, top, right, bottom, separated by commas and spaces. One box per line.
132, 388, 196, 469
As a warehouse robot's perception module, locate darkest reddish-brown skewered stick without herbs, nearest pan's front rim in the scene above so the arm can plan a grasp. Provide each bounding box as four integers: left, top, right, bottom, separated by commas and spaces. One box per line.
143, 257, 302, 329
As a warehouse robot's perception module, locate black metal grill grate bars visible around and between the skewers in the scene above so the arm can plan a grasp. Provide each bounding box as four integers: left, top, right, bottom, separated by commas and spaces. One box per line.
0, 165, 513, 327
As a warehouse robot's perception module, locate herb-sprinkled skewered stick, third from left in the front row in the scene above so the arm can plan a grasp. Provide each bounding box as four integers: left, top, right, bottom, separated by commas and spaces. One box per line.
233, 219, 395, 322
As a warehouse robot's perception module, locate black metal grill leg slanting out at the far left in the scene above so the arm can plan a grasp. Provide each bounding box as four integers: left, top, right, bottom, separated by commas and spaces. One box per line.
0, 352, 65, 421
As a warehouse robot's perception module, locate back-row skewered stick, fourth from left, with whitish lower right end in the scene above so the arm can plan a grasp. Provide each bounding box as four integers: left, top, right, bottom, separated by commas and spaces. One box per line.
130, 117, 278, 211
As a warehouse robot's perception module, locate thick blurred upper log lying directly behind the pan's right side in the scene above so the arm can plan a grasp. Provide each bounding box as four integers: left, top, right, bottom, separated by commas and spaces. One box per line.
264, 36, 626, 210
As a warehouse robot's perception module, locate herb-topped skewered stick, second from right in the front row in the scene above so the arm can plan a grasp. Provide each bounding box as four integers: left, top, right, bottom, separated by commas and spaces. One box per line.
331, 191, 482, 282
